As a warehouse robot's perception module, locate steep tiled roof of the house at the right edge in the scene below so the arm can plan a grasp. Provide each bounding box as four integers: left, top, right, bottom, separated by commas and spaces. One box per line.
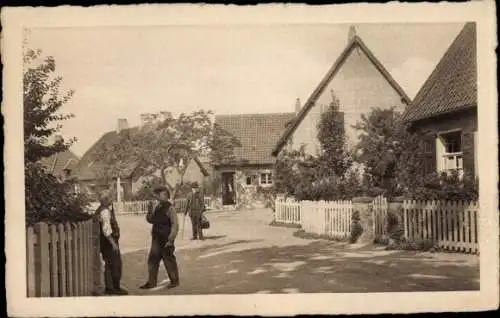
403, 22, 477, 122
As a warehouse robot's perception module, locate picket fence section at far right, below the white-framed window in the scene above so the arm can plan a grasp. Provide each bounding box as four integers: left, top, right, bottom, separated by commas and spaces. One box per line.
403, 200, 479, 253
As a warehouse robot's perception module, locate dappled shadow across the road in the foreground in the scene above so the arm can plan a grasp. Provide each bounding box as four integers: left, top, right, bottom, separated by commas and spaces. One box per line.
124, 241, 479, 294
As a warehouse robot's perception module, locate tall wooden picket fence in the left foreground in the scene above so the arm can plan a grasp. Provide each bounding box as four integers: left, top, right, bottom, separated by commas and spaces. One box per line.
26, 220, 97, 297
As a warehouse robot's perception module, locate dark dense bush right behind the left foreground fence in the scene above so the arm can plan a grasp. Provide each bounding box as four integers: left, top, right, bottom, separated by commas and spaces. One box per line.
24, 163, 91, 225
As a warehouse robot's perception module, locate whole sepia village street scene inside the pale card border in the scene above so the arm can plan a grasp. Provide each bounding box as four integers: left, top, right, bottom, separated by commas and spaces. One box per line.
2, 1, 498, 315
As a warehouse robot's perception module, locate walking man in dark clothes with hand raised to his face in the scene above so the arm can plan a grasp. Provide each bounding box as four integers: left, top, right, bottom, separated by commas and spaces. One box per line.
140, 187, 179, 289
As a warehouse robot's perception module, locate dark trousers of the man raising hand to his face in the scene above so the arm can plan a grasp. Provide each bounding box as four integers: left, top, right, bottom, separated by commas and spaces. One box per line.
148, 236, 179, 286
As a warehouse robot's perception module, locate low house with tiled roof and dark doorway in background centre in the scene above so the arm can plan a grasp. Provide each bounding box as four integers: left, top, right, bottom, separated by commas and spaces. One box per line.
213, 112, 295, 208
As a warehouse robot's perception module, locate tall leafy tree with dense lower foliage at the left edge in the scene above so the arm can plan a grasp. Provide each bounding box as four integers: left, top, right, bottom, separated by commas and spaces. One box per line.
23, 49, 88, 224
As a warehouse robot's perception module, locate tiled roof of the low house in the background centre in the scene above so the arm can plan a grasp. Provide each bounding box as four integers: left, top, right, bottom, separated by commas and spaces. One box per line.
215, 113, 295, 164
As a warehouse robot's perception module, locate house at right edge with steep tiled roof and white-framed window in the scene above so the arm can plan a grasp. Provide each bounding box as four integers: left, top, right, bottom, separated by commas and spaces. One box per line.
403, 22, 478, 176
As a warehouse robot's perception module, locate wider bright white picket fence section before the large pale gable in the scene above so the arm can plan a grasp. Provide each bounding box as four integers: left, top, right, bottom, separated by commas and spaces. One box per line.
301, 201, 352, 239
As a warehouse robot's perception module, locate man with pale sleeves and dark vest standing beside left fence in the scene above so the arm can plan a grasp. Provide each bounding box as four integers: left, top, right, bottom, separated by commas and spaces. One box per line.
95, 192, 128, 295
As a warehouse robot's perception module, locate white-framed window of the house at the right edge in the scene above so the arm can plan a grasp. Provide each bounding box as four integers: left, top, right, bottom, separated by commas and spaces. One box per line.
437, 131, 463, 175
